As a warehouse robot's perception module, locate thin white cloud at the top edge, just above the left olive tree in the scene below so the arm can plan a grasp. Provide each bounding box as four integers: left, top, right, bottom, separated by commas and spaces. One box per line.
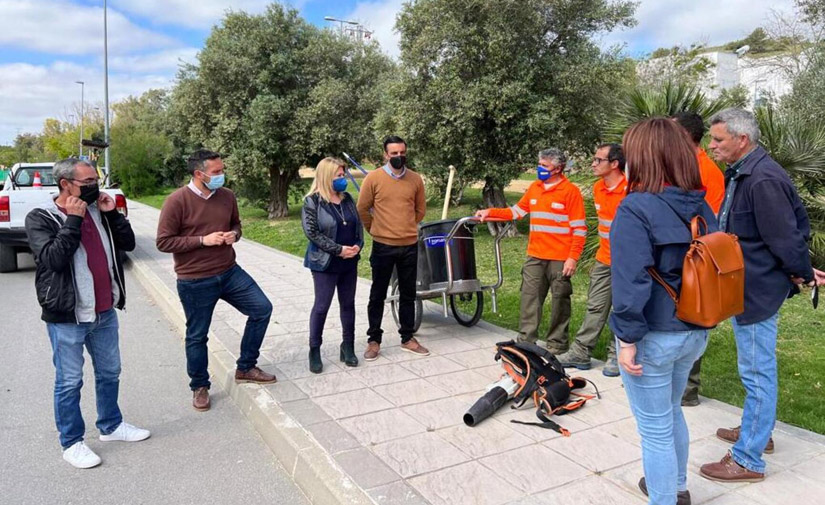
108, 0, 296, 30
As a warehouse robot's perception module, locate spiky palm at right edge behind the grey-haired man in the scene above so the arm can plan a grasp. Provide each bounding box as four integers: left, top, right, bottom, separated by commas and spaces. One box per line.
756, 105, 825, 267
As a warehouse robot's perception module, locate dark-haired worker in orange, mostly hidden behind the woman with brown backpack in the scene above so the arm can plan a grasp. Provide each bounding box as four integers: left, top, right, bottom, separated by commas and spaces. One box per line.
673, 112, 725, 407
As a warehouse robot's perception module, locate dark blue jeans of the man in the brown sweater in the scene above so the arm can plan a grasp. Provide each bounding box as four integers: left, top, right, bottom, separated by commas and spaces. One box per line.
178, 265, 272, 391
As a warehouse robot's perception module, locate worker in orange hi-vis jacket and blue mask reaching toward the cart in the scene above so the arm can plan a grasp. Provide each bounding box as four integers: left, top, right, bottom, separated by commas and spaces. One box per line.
476, 149, 587, 354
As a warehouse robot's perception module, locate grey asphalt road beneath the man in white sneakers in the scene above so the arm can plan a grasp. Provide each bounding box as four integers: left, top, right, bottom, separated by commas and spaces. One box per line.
0, 255, 308, 505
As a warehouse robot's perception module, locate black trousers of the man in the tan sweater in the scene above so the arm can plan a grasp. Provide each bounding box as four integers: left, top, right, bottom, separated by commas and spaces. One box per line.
367, 241, 418, 344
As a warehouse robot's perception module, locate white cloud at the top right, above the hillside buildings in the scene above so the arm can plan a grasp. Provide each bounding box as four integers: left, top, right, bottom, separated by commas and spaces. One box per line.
603, 0, 794, 56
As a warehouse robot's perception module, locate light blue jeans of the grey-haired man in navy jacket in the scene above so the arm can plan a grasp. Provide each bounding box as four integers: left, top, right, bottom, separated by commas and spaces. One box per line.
731, 312, 779, 473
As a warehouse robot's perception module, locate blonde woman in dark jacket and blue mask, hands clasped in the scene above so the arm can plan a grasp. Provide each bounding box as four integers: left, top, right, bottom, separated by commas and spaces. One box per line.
301, 158, 364, 373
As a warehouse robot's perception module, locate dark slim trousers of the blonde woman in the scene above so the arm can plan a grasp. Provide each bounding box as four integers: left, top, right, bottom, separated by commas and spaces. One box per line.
309, 268, 358, 347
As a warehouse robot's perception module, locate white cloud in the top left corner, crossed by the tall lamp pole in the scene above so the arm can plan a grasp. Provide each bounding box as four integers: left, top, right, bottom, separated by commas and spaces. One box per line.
0, 0, 177, 55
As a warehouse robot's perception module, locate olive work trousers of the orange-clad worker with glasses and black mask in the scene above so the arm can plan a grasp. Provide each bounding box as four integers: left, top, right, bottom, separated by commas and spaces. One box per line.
573, 261, 616, 358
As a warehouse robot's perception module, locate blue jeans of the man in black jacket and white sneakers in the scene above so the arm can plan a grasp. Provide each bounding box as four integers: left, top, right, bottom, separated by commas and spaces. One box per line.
46, 309, 123, 449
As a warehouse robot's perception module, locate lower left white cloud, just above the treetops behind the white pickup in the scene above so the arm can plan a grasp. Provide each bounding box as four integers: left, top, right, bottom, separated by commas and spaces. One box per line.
0, 62, 173, 145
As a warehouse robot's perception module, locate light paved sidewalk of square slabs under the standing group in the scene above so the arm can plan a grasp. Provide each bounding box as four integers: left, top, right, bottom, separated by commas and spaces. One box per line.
124, 202, 825, 505
